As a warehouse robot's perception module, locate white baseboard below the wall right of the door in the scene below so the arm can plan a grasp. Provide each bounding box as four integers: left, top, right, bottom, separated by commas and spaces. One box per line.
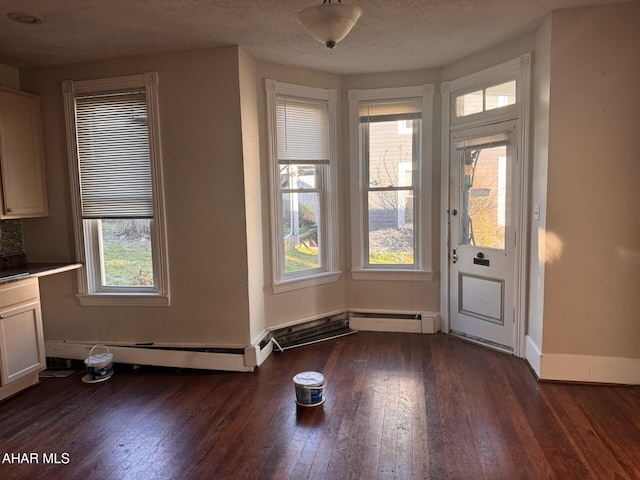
539, 353, 640, 385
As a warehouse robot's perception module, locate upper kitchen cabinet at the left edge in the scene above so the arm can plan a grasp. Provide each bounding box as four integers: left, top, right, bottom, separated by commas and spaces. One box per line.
0, 87, 48, 219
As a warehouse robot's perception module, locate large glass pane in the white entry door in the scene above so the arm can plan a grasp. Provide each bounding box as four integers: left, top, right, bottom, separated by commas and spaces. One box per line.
460, 145, 507, 249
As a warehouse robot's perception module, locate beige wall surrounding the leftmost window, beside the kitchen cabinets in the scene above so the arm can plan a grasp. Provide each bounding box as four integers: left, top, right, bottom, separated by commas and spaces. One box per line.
21, 47, 255, 345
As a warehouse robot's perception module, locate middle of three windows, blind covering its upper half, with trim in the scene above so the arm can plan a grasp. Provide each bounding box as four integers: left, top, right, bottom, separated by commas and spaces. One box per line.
266, 80, 340, 293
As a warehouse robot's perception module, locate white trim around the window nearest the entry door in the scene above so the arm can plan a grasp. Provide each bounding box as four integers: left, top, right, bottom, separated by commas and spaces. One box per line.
348, 84, 434, 281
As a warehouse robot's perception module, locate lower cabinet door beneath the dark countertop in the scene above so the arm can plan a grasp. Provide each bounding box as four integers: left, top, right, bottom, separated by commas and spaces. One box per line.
0, 301, 46, 386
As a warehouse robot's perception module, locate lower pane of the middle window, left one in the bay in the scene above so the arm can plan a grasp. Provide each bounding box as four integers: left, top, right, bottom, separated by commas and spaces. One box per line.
282, 192, 321, 273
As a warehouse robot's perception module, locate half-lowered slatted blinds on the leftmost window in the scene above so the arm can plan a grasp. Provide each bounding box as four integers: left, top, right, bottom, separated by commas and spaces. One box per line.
75, 89, 153, 218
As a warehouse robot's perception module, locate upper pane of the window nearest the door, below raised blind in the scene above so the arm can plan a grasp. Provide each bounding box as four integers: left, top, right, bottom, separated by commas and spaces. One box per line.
368, 120, 420, 187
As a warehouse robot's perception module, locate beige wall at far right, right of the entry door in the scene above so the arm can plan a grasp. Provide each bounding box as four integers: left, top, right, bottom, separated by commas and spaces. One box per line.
543, 3, 640, 359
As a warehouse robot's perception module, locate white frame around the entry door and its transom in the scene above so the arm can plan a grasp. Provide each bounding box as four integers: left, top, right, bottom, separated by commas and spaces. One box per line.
440, 53, 531, 357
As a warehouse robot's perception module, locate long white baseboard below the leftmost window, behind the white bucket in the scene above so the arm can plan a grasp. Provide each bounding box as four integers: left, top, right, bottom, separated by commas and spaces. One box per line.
45, 340, 255, 372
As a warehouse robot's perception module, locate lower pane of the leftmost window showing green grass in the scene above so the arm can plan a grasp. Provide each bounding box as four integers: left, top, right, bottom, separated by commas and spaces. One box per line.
100, 219, 154, 287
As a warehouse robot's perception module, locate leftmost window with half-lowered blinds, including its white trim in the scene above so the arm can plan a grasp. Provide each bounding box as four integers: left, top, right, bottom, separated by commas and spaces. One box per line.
63, 72, 170, 306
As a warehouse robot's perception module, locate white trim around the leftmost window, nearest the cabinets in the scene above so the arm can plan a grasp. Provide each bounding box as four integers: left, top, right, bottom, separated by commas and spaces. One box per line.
62, 72, 170, 306
